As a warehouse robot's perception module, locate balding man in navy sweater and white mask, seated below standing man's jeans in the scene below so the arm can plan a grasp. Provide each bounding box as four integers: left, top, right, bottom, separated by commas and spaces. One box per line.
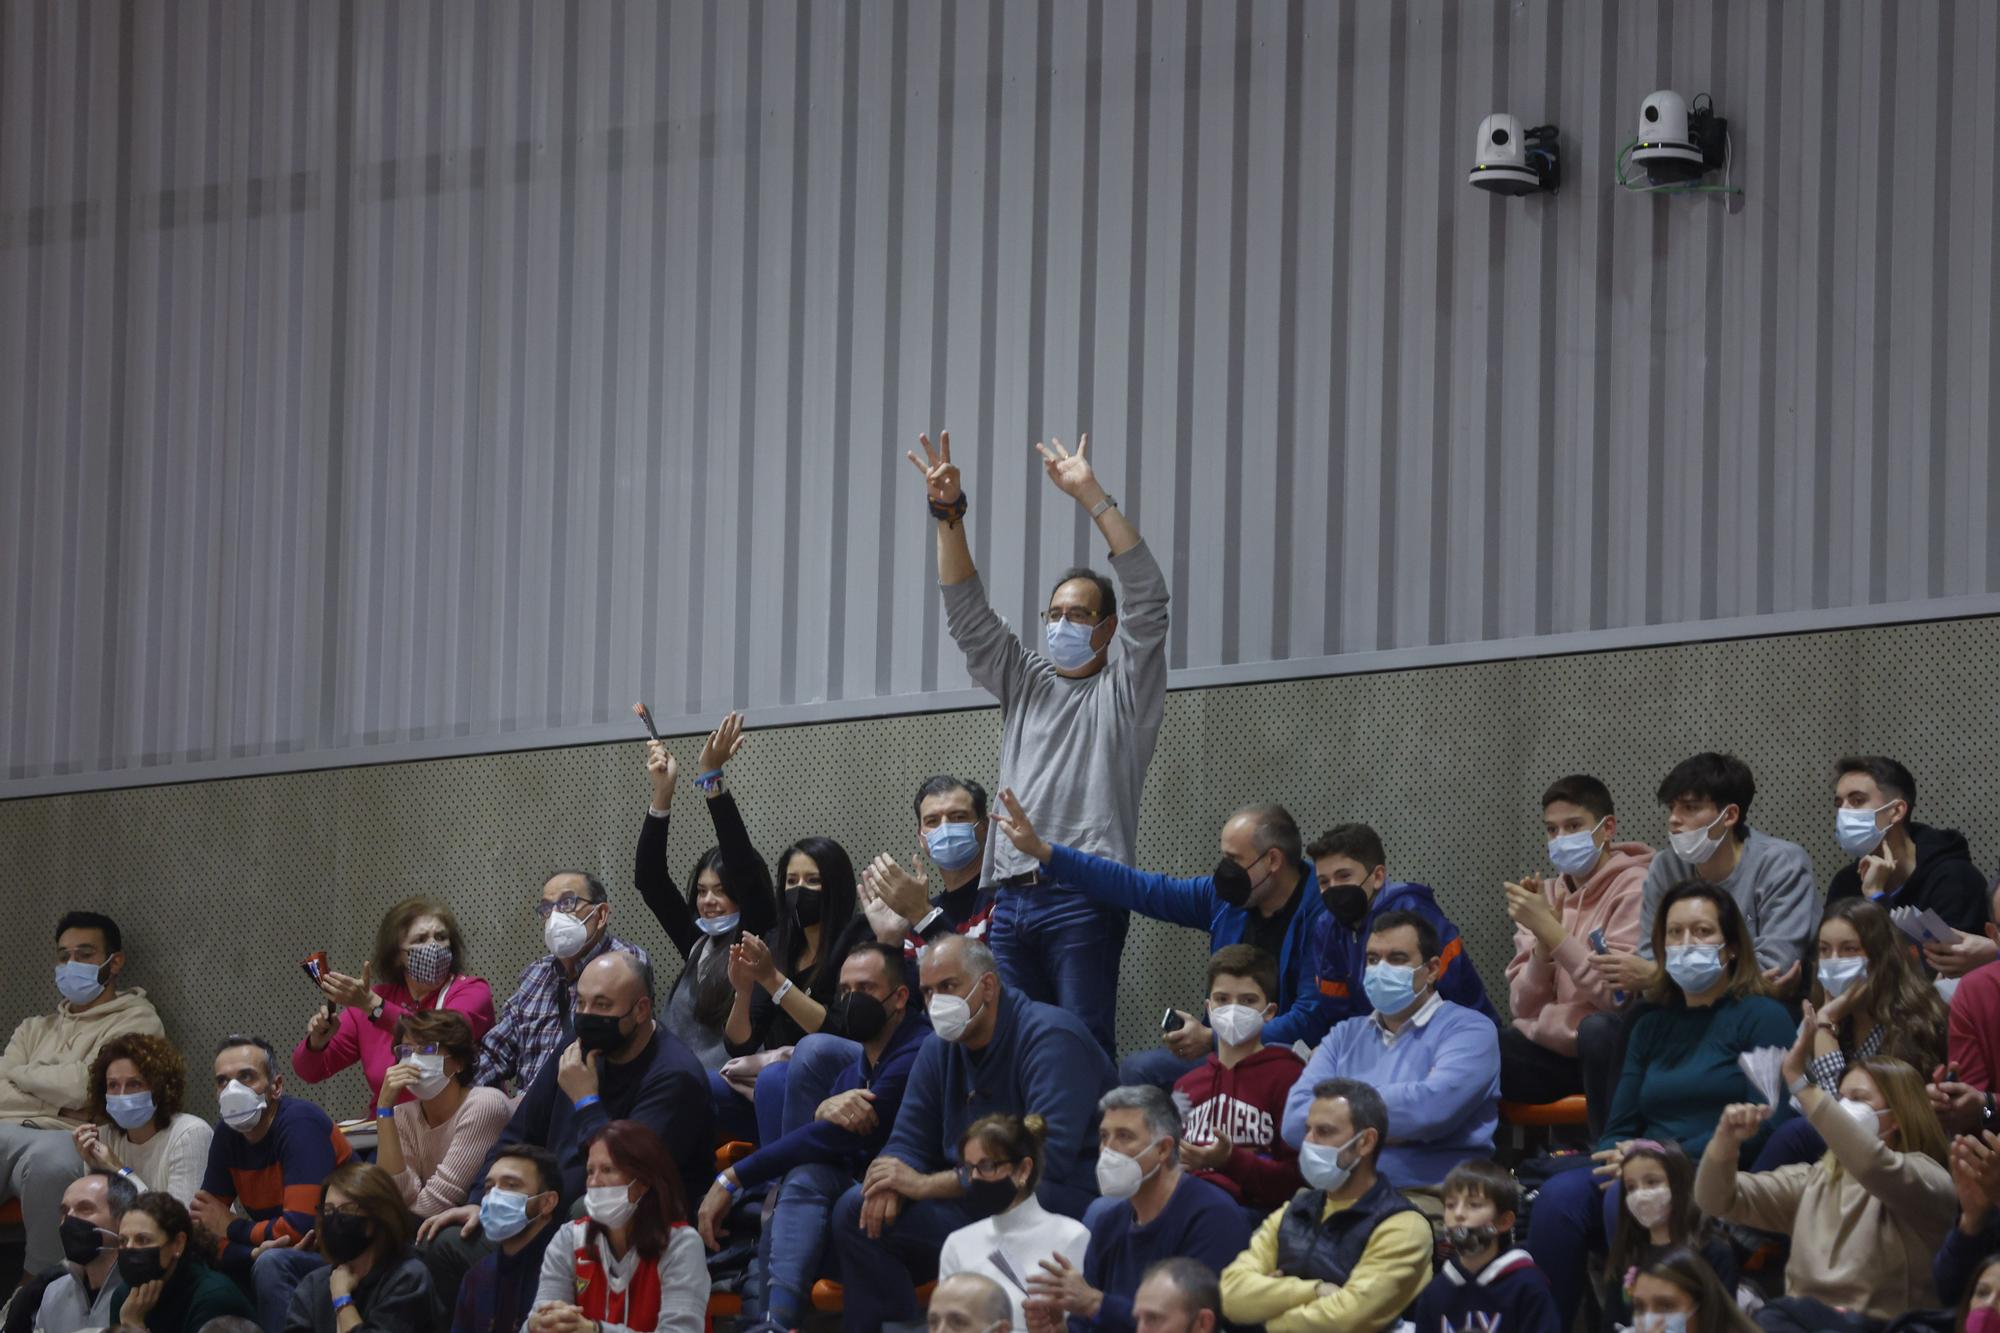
834, 935, 1112, 1329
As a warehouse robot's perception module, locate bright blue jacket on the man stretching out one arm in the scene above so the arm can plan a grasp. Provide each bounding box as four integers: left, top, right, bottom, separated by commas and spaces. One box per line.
1048, 847, 1336, 1047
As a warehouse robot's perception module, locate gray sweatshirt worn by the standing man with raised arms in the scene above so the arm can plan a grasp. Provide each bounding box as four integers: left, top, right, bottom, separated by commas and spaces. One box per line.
944, 542, 1166, 885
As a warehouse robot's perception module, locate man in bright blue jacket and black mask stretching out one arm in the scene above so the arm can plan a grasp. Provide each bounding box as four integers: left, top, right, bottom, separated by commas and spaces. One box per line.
996, 791, 1334, 1089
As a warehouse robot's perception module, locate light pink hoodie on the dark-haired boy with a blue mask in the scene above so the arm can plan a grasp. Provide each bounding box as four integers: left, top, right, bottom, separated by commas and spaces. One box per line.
1506, 843, 1652, 1055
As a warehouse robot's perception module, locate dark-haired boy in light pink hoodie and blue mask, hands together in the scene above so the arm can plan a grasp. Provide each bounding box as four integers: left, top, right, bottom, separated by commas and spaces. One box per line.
1500, 775, 1652, 1137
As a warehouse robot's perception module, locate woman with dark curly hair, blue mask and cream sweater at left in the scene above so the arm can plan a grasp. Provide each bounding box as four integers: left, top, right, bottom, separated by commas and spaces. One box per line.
72, 1033, 216, 1205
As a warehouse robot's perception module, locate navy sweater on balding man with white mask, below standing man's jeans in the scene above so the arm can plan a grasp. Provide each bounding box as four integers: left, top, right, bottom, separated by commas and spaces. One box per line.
882, 991, 1118, 1217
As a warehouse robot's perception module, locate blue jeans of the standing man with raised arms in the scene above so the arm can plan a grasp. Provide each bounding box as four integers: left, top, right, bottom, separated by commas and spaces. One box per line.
986, 883, 1130, 1061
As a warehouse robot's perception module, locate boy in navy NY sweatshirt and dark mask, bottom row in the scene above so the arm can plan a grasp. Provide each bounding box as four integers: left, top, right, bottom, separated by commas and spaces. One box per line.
1416, 1161, 1562, 1333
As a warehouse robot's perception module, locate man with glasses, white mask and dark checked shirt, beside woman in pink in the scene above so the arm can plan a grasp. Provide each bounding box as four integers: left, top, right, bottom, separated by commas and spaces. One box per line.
472, 871, 648, 1089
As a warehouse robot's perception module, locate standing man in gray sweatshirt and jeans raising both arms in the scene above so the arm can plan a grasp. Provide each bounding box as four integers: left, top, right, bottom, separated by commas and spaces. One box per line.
910, 432, 1168, 1053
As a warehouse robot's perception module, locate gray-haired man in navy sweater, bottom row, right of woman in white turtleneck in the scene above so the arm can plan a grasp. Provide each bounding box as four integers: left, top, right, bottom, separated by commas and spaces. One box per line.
1028, 1083, 1250, 1329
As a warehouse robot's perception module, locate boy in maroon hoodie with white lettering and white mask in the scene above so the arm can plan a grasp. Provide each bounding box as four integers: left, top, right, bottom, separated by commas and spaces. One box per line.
1174, 945, 1306, 1221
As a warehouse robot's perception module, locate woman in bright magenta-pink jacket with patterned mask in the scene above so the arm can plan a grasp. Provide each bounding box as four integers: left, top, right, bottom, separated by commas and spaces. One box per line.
292, 899, 494, 1115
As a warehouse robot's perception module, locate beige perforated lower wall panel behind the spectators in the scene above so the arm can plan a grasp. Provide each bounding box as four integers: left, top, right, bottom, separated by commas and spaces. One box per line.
0, 620, 2000, 1115
